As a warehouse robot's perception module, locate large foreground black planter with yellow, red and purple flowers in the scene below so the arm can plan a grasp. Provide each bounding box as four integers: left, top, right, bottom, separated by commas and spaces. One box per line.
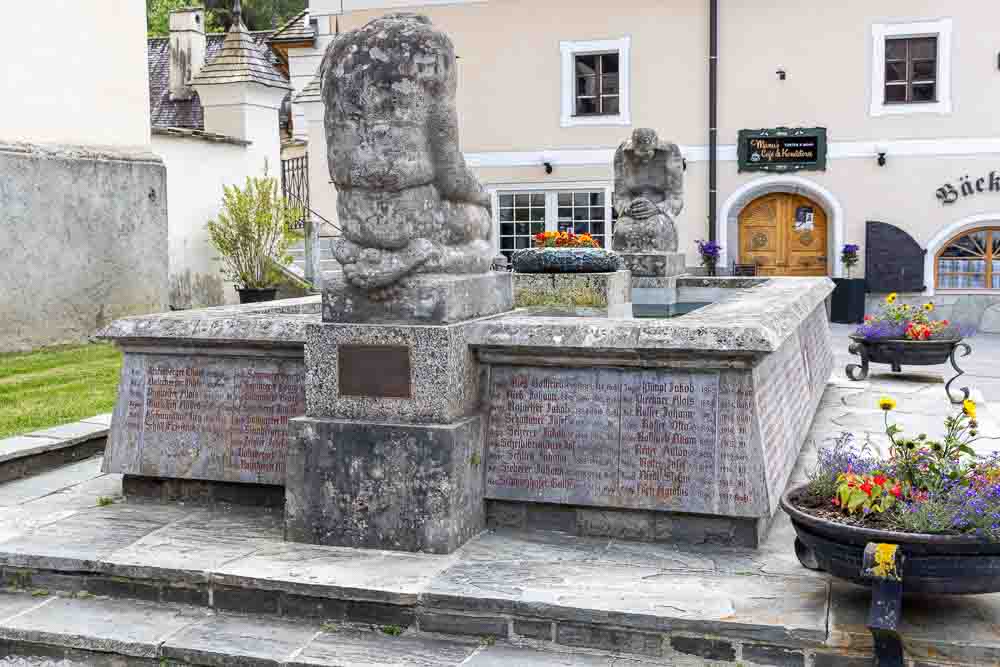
781, 397, 1000, 667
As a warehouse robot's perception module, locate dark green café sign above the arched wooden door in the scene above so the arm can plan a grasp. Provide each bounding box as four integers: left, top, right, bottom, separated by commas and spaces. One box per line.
738, 127, 826, 172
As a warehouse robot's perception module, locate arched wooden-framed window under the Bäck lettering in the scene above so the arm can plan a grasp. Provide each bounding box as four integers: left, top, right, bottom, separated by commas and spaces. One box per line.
936, 227, 1000, 289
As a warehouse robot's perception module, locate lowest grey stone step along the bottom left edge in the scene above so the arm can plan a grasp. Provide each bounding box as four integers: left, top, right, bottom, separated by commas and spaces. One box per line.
0, 591, 672, 667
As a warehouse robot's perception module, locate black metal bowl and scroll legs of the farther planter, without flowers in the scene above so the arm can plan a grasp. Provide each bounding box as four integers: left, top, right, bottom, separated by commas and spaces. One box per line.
845, 334, 972, 403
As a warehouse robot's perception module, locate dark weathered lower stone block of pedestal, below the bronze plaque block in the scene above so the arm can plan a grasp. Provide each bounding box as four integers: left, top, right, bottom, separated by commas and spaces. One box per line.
285, 416, 484, 553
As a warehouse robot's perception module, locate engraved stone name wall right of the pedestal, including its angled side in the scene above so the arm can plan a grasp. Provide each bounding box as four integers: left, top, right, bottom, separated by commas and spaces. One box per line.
486, 304, 833, 518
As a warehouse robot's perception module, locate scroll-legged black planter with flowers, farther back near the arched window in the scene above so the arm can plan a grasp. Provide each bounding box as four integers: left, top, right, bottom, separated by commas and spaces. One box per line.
845, 292, 972, 403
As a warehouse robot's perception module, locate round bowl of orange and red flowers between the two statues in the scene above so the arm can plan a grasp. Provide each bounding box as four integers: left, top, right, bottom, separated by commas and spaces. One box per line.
511, 231, 622, 273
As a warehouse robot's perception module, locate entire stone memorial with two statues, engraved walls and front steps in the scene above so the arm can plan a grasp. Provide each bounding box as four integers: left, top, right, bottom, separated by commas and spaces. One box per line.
9, 15, 984, 667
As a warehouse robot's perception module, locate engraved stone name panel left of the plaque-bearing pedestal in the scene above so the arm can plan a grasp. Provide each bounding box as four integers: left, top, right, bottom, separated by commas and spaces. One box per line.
104, 352, 305, 485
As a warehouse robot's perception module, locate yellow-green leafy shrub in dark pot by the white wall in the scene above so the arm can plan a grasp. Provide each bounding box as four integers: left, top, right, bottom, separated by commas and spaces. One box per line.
207, 173, 302, 303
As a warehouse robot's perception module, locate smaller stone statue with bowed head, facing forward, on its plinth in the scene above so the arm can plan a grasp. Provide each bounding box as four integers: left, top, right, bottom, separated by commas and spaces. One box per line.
614, 128, 685, 278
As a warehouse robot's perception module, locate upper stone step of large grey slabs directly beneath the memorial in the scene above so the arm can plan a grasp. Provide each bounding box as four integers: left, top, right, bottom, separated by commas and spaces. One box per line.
0, 461, 1000, 667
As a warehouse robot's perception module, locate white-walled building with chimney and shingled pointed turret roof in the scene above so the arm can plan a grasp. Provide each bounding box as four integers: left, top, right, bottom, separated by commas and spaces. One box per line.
148, 7, 290, 308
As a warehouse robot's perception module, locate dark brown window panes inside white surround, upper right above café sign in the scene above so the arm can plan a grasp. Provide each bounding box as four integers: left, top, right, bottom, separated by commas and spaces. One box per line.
885, 37, 938, 104
